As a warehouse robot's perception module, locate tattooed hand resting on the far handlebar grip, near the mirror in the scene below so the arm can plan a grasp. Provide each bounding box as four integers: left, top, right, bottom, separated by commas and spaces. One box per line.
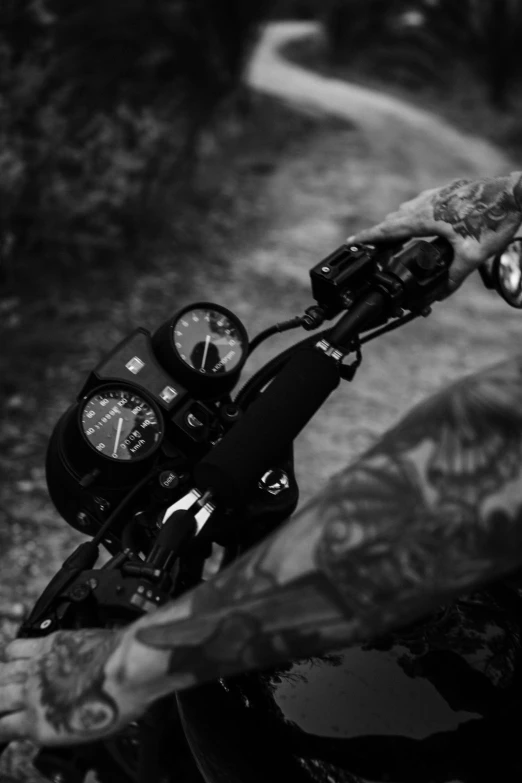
348, 171, 522, 293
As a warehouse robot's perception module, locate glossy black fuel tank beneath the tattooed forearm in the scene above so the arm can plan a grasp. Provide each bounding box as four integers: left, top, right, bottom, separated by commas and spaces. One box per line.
178, 584, 522, 783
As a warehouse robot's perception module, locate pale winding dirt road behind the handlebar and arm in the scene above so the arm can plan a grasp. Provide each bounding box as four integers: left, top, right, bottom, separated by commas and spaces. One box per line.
201, 23, 521, 499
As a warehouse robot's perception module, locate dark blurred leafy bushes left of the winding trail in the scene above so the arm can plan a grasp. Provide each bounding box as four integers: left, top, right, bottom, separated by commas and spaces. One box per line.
0, 0, 267, 290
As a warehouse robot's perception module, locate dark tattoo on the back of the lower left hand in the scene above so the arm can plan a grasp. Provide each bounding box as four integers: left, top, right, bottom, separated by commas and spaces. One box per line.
37, 630, 120, 738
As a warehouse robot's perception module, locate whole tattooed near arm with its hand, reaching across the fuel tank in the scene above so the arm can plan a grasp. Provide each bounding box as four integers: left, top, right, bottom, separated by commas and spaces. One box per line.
0, 356, 522, 744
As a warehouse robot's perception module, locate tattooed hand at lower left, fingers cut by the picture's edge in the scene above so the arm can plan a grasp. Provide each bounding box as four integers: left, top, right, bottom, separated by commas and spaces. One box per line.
0, 629, 150, 745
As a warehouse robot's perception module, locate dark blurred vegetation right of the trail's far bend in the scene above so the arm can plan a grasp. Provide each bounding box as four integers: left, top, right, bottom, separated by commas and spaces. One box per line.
287, 0, 522, 161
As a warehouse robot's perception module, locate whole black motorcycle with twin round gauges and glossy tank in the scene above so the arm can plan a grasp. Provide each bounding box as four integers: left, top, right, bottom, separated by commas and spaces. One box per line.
1, 239, 522, 783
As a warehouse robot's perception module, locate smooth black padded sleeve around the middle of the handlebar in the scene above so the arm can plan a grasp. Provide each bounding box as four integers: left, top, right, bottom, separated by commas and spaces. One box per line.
194, 348, 340, 504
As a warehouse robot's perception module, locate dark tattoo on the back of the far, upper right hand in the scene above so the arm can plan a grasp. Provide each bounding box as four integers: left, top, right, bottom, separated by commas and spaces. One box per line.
433, 175, 522, 241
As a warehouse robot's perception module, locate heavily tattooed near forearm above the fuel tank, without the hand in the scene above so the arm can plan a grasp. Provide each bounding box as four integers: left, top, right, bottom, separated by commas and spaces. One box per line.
131, 357, 522, 687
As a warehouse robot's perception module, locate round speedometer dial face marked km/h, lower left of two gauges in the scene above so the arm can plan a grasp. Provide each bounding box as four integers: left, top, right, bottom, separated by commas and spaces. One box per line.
80, 388, 163, 461
